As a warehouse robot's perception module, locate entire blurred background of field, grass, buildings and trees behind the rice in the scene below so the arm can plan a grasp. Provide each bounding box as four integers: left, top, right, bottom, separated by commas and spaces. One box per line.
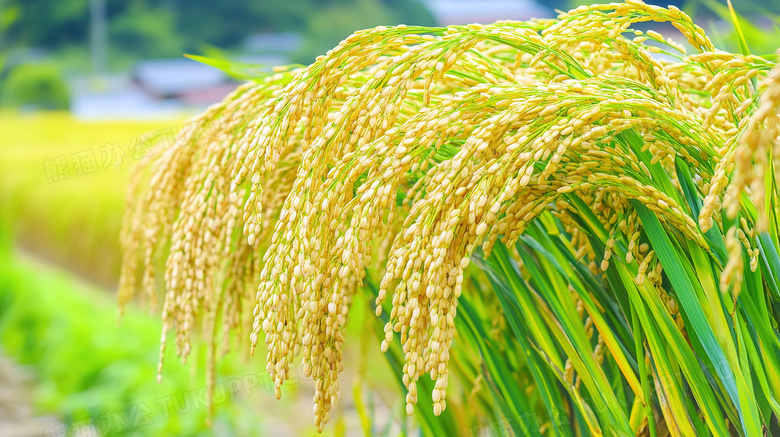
0, 0, 780, 437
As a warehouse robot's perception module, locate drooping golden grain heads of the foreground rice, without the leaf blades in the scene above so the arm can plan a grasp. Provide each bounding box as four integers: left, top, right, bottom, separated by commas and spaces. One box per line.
120, 0, 780, 430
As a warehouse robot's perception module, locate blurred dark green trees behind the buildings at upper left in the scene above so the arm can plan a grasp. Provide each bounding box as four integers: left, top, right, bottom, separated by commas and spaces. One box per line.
0, 0, 433, 66
